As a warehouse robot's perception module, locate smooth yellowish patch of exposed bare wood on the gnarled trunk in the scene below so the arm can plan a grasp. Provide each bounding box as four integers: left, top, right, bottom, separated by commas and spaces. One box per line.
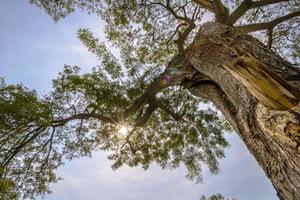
224, 53, 299, 110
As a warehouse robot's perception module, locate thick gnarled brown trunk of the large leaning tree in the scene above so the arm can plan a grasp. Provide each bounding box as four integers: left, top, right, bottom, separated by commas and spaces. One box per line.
186, 23, 300, 199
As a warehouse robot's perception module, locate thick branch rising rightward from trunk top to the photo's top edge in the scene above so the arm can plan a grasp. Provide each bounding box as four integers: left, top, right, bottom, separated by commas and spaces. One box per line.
226, 0, 290, 25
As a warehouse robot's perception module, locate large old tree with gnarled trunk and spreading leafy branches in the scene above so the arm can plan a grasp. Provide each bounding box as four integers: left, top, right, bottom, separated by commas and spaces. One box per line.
0, 0, 300, 199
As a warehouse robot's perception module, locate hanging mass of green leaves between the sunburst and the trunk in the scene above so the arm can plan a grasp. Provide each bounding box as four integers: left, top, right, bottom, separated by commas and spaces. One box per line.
102, 89, 228, 182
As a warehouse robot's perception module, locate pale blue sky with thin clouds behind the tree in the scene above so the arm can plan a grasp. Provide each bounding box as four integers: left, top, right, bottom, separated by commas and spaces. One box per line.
0, 0, 278, 200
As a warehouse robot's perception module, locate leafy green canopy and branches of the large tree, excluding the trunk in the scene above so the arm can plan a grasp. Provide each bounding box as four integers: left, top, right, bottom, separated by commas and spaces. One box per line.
0, 0, 300, 198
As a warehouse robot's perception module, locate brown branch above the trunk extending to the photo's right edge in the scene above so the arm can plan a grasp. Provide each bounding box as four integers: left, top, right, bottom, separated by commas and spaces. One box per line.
237, 11, 300, 33
